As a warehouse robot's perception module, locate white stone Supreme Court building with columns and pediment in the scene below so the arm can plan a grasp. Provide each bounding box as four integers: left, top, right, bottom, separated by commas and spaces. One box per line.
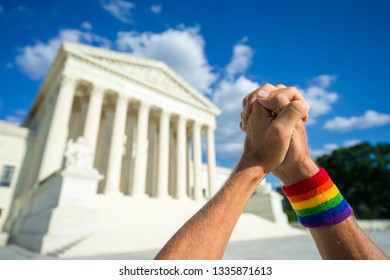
0, 43, 286, 253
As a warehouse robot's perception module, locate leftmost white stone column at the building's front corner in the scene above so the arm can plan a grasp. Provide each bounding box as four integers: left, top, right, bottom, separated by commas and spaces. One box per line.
38, 75, 77, 181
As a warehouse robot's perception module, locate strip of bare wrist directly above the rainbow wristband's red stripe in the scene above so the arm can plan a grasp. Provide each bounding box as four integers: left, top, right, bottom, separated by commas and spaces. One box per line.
274, 158, 320, 186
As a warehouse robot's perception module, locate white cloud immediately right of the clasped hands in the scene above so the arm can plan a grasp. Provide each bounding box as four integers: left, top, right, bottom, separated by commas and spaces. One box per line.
299, 75, 339, 124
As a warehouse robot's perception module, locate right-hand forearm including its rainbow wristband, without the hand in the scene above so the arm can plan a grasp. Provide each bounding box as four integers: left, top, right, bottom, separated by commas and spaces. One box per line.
284, 164, 388, 259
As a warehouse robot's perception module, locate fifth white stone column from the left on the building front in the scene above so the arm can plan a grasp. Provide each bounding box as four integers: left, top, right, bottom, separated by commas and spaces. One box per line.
157, 110, 170, 197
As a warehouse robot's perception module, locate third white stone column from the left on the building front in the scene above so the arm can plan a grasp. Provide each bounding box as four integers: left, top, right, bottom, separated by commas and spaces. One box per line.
104, 96, 128, 194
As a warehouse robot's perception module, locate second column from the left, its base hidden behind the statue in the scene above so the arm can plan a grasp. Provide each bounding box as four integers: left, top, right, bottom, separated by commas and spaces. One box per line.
83, 86, 104, 156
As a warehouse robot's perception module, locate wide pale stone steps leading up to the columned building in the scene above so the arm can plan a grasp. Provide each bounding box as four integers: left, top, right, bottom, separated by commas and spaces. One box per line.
59, 196, 304, 258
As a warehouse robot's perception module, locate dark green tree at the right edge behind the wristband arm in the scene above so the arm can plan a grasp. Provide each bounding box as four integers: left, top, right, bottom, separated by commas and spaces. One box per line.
317, 143, 390, 219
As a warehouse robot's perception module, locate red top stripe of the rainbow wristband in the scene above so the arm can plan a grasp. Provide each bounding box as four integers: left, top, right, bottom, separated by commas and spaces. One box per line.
282, 168, 329, 197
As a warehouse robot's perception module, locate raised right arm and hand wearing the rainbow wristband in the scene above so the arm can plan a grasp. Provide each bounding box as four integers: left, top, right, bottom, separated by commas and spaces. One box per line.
240, 84, 388, 259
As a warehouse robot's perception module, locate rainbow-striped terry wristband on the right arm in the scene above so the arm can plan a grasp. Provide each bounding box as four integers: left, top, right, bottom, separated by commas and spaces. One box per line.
283, 168, 353, 228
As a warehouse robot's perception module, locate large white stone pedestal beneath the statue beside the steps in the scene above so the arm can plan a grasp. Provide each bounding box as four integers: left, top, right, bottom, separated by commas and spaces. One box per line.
9, 168, 102, 254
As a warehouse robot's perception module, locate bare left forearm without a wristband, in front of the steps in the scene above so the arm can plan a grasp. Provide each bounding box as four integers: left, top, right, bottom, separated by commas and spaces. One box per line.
156, 157, 265, 259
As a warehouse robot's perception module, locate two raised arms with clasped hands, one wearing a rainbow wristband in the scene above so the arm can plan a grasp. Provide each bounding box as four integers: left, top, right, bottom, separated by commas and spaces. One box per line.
156, 84, 388, 259
